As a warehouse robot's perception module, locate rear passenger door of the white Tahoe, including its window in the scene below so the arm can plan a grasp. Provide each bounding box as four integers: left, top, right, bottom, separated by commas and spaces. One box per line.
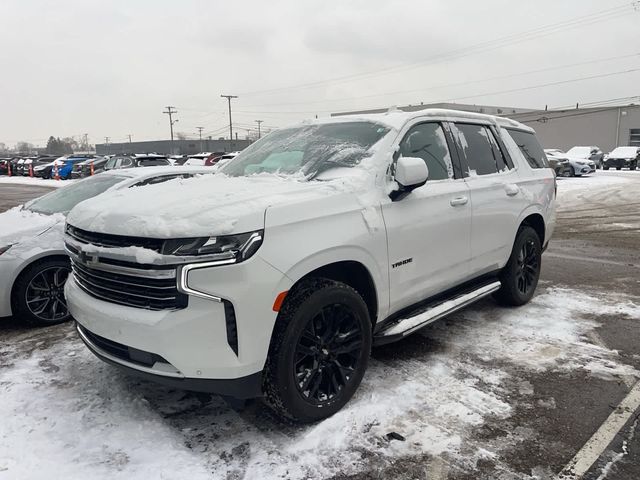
452, 122, 522, 276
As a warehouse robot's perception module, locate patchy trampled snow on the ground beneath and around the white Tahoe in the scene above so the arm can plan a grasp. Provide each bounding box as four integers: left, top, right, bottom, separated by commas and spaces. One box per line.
0, 288, 640, 479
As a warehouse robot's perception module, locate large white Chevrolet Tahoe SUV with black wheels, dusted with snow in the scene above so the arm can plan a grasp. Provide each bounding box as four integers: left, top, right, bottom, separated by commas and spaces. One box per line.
66, 110, 555, 421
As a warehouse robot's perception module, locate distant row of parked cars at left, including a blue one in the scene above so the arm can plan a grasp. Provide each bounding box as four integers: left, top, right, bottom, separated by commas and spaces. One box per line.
0, 152, 239, 180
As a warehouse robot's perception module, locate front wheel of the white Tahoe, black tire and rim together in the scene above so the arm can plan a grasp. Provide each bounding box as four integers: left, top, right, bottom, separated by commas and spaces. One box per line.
263, 278, 372, 423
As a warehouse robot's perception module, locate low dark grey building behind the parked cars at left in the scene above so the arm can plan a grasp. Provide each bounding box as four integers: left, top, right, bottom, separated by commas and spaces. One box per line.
96, 139, 251, 155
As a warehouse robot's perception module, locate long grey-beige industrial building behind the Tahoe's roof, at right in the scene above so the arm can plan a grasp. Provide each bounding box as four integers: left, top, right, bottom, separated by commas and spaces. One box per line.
332, 103, 640, 152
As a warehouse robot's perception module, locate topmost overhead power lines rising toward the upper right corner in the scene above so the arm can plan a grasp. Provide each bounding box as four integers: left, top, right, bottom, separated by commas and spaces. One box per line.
242, 2, 636, 96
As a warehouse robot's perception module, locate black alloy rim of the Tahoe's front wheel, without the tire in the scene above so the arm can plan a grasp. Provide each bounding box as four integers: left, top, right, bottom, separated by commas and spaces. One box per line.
293, 304, 364, 405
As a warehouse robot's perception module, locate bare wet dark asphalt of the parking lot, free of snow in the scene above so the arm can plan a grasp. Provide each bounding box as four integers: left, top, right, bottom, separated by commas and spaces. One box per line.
0, 176, 640, 480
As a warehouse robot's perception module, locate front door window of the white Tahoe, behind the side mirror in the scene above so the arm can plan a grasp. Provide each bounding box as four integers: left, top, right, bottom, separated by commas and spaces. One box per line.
400, 123, 453, 180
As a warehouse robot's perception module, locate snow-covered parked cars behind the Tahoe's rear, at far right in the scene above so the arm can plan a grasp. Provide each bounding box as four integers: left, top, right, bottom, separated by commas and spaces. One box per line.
544, 146, 640, 177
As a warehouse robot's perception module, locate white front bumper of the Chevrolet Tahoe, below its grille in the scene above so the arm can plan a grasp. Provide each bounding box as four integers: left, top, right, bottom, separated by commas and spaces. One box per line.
65, 256, 290, 396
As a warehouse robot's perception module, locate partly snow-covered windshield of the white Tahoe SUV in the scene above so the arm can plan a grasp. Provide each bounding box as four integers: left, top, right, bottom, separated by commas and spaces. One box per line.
220, 121, 389, 179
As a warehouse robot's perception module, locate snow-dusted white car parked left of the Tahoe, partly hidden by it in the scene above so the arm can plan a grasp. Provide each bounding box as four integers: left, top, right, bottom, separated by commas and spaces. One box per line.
0, 167, 215, 325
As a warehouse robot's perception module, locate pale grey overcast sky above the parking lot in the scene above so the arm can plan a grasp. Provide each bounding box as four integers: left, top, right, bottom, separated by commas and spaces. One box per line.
0, 0, 640, 145
